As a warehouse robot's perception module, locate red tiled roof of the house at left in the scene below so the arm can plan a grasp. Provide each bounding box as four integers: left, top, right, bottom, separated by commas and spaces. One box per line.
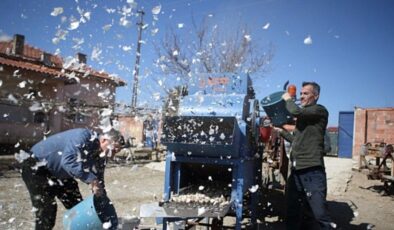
0, 41, 126, 86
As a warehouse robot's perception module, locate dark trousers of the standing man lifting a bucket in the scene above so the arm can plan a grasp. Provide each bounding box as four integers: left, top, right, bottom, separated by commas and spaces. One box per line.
286, 167, 333, 229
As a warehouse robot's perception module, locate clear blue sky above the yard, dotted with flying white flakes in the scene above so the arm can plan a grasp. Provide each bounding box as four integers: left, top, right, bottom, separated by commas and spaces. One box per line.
0, 0, 394, 126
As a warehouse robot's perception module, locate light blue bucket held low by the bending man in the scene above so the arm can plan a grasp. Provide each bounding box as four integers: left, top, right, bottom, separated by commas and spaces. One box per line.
63, 196, 118, 230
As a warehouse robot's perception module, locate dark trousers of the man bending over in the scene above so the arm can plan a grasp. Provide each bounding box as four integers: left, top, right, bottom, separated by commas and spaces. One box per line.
22, 158, 82, 230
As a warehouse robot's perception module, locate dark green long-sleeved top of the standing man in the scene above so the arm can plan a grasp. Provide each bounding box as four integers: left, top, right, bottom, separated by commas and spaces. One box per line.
281, 100, 328, 170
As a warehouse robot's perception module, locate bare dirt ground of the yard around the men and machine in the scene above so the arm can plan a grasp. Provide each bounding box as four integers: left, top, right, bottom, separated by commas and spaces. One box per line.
0, 157, 394, 230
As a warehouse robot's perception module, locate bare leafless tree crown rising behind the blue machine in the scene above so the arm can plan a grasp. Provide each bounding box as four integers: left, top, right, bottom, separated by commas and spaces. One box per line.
155, 16, 273, 82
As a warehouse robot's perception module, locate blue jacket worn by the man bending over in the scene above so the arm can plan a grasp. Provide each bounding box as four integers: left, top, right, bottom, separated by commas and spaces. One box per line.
31, 128, 106, 183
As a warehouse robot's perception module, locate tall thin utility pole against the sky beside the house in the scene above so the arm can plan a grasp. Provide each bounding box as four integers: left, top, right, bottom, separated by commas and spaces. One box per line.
131, 10, 145, 112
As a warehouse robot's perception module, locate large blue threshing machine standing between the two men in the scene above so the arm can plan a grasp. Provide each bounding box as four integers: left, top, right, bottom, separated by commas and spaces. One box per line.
162, 74, 262, 229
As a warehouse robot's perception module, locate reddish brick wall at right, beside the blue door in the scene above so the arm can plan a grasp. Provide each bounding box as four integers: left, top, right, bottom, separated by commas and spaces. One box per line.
353, 108, 394, 158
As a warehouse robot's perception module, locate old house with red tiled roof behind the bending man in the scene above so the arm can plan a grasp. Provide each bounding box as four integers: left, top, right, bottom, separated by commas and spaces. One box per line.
0, 35, 125, 149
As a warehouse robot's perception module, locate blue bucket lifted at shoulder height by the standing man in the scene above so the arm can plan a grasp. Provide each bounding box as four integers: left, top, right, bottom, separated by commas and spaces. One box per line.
260, 91, 293, 126
